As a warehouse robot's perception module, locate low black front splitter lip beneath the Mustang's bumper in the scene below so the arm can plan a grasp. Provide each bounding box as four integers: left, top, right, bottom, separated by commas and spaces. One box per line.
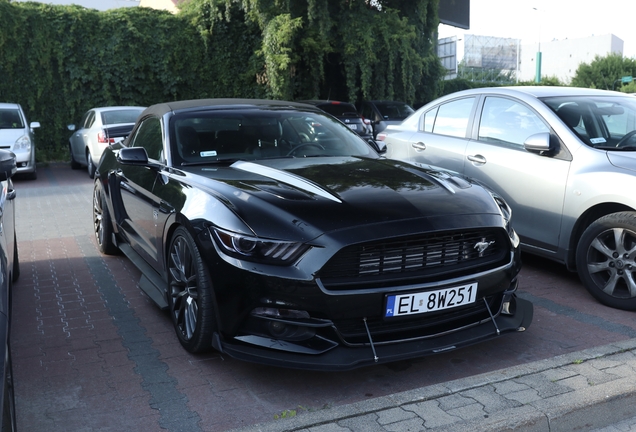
214, 294, 533, 371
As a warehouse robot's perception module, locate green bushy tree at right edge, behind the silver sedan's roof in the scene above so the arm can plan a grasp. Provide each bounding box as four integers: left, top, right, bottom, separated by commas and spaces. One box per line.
571, 53, 636, 90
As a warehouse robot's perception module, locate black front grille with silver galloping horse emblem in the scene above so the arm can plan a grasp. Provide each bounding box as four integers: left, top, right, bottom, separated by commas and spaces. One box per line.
320, 229, 510, 290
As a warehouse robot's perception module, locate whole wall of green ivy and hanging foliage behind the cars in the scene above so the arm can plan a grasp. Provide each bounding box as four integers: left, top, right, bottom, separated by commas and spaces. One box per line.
0, 0, 442, 161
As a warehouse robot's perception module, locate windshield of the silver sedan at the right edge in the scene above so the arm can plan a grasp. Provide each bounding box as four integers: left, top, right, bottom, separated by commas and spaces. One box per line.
542, 96, 636, 151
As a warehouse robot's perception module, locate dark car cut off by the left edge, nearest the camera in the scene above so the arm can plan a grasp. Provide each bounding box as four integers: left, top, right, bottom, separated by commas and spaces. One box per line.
0, 150, 20, 431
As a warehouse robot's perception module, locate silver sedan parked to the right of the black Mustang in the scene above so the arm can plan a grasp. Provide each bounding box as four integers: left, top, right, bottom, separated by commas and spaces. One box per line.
378, 87, 636, 310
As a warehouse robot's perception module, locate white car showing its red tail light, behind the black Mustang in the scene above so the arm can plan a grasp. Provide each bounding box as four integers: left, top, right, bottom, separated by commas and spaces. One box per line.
68, 106, 145, 178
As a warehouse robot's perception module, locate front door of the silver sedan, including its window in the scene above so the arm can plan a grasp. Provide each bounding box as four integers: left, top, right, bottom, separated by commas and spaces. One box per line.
463, 96, 571, 251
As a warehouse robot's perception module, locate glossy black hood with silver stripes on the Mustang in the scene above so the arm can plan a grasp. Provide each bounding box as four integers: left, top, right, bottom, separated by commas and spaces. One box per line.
180, 157, 500, 239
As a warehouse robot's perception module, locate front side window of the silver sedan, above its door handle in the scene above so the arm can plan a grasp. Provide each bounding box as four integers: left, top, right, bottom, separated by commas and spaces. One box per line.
479, 97, 550, 147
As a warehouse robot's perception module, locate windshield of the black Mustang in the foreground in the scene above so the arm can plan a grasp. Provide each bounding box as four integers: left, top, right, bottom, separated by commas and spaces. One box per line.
170, 109, 379, 166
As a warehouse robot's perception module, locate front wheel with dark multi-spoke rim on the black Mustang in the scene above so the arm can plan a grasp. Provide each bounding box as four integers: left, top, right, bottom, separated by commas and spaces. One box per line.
168, 227, 217, 353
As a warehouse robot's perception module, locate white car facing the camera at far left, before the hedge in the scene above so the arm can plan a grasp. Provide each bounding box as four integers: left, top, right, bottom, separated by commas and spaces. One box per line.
0, 103, 40, 180
